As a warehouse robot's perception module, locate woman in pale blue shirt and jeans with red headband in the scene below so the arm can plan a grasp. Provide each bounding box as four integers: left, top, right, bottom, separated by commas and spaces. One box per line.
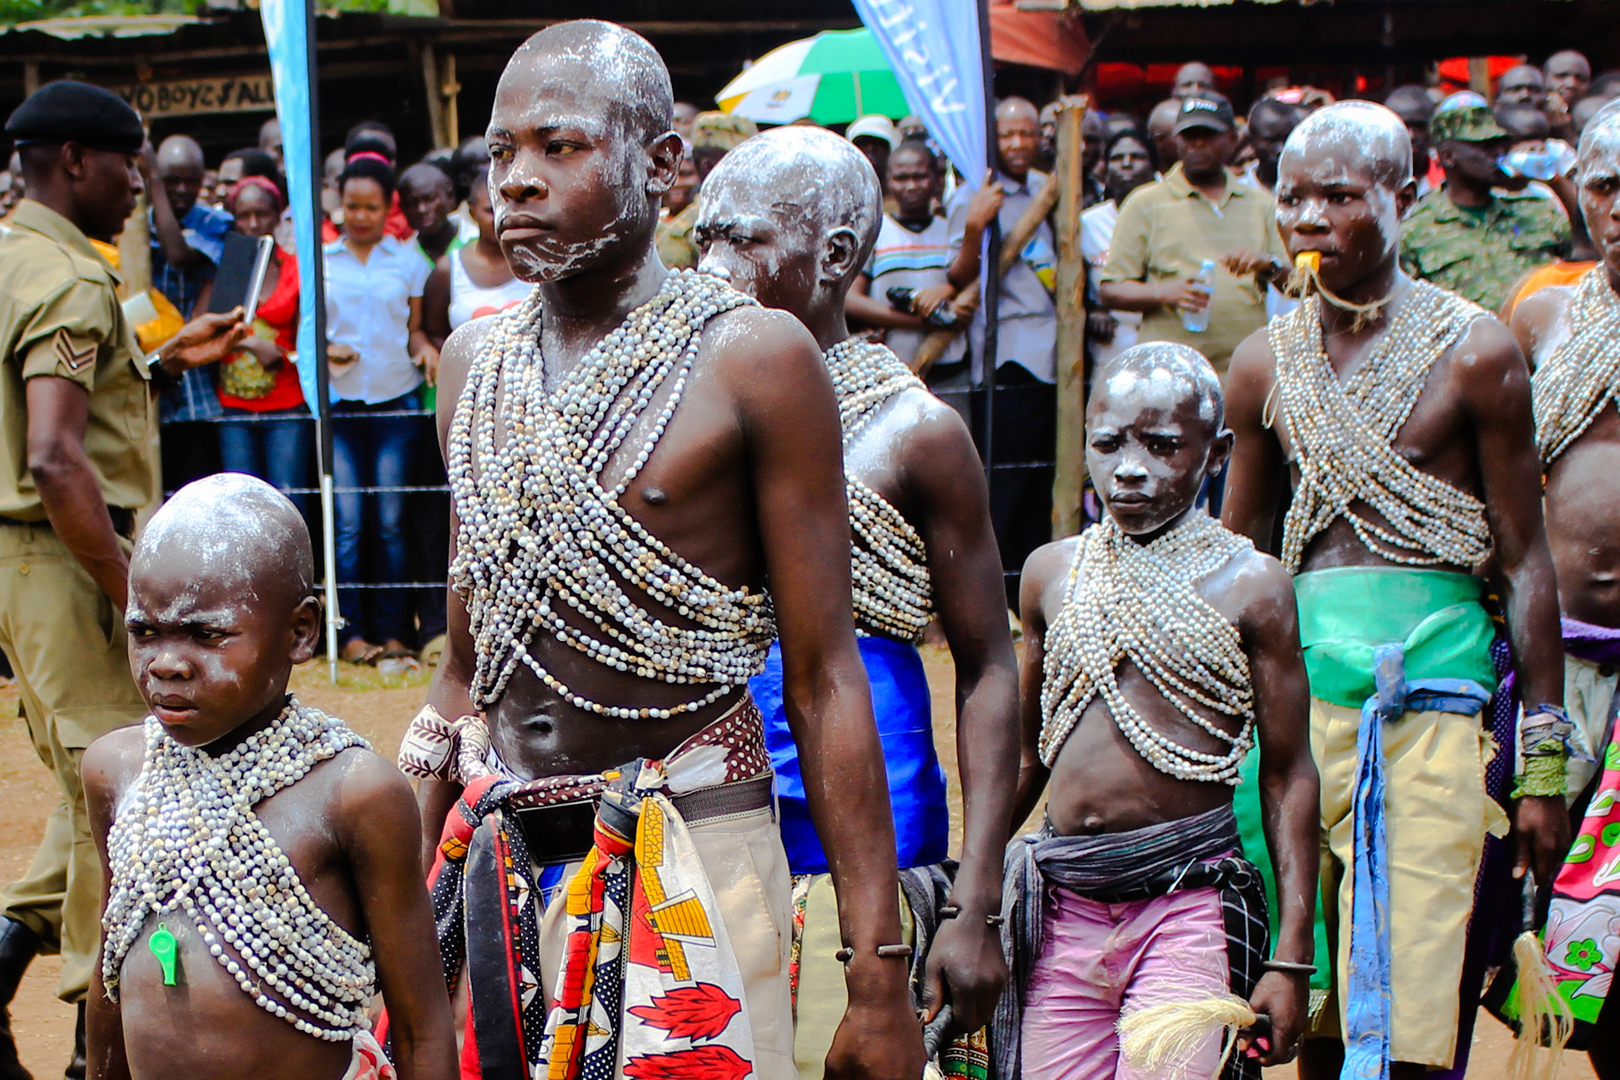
324, 152, 439, 667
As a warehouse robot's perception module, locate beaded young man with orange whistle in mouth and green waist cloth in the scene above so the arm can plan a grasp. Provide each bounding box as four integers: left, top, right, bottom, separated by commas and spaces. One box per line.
1223, 102, 1568, 1077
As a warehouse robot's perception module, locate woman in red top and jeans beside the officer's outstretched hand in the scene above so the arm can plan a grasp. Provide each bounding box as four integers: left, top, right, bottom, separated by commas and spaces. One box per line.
219, 176, 314, 512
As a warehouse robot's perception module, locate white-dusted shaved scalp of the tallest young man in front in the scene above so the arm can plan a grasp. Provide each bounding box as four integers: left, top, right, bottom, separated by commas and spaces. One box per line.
511, 19, 676, 144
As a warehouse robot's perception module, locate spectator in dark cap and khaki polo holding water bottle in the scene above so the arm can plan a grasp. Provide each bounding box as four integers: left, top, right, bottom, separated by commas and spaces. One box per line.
1098, 94, 1286, 374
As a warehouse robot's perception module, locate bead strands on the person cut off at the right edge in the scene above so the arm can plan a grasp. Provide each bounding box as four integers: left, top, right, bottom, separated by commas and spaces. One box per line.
1529, 267, 1620, 466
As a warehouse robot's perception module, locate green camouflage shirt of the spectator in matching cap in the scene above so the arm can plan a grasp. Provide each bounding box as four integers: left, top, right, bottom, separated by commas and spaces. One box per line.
1401, 188, 1570, 311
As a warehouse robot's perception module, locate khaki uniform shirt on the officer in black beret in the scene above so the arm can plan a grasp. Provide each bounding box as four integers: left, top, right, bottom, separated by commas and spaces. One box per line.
0, 199, 159, 521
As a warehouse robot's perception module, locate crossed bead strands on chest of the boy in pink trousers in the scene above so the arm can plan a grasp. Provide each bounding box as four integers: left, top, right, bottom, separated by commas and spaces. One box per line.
1040, 512, 1254, 785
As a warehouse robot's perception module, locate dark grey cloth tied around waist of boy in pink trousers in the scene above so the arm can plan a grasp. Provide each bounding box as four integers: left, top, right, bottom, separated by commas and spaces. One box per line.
990, 805, 1270, 1080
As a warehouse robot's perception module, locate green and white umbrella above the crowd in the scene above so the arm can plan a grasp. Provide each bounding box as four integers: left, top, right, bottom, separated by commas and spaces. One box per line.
714, 28, 910, 123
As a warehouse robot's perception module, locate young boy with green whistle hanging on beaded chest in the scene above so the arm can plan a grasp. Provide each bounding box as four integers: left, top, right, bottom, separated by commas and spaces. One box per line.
84, 473, 455, 1080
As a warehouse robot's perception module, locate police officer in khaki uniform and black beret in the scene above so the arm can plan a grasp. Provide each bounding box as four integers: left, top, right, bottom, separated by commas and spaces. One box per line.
0, 81, 246, 1080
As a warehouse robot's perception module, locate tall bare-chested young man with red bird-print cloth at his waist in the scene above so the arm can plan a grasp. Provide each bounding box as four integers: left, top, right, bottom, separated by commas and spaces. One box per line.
402, 21, 922, 1080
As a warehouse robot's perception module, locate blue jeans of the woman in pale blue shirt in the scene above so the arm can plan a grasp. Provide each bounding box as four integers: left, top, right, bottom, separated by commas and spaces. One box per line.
332, 390, 421, 644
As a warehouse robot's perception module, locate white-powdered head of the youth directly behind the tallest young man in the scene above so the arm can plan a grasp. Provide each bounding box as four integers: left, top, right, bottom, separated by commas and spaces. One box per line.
695, 126, 883, 337
